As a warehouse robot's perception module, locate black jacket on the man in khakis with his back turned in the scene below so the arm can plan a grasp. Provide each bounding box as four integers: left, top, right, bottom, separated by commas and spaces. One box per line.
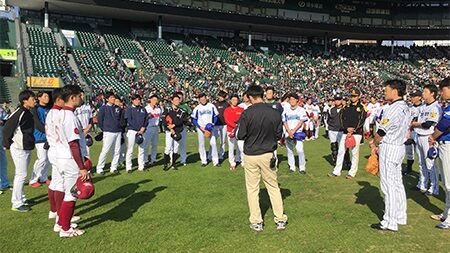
237, 103, 283, 155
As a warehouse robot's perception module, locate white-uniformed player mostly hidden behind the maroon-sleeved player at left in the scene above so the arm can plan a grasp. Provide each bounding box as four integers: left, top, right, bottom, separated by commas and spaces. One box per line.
45, 88, 81, 229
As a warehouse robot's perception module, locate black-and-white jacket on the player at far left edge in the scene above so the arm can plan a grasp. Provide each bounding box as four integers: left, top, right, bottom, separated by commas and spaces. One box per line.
3, 106, 34, 150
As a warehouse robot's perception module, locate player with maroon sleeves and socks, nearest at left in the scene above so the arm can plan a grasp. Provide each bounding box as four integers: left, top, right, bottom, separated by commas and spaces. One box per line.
47, 85, 90, 237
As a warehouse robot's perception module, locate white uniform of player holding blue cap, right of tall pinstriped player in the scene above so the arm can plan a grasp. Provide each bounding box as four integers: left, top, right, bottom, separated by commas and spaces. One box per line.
414, 101, 442, 195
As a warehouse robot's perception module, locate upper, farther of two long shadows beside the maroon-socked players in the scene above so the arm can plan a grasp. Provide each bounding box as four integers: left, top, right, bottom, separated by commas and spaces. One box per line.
76, 179, 152, 215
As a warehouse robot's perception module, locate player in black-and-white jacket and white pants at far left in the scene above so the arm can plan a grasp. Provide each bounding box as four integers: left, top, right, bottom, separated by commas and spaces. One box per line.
3, 90, 36, 212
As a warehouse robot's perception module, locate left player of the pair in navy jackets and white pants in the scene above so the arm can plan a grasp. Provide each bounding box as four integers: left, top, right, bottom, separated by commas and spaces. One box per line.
97, 92, 122, 175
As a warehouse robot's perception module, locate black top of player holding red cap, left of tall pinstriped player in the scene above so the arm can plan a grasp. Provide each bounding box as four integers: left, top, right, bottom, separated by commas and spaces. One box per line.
341, 101, 366, 135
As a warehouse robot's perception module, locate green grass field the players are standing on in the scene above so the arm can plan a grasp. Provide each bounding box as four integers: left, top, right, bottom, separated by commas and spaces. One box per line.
0, 131, 450, 252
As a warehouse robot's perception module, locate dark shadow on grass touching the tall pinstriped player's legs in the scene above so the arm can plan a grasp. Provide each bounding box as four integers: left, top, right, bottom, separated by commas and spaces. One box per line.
355, 181, 384, 220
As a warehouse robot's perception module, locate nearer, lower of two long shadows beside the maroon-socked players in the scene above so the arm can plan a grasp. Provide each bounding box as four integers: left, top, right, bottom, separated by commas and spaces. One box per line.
80, 186, 167, 228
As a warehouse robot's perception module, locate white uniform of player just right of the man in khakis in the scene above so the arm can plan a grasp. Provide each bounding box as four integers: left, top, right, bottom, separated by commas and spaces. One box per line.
281, 106, 308, 171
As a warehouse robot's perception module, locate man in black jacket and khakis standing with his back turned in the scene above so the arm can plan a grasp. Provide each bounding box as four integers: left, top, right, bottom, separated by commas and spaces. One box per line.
237, 85, 288, 231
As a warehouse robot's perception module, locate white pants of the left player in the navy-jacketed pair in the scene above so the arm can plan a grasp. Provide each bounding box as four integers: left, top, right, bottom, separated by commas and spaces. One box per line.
97, 132, 121, 173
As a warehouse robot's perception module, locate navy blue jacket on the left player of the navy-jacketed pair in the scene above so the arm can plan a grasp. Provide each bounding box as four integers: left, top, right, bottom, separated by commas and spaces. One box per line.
97, 104, 122, 133
